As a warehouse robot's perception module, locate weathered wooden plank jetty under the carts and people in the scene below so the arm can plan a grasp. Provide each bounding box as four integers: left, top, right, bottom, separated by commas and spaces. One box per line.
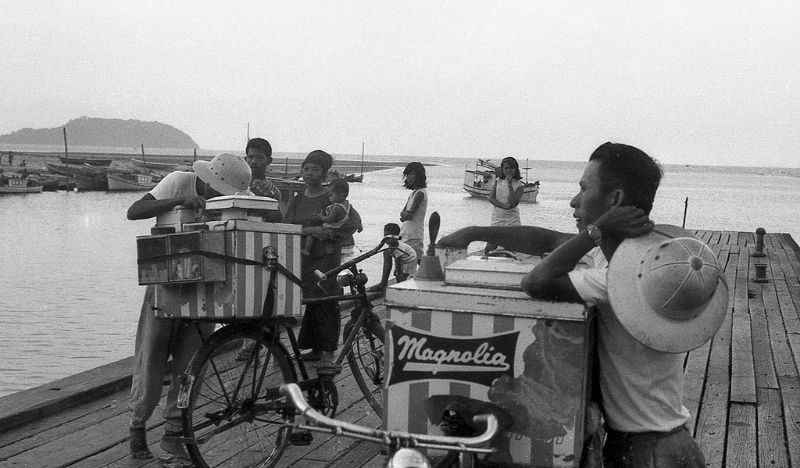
0, 231, 800, 468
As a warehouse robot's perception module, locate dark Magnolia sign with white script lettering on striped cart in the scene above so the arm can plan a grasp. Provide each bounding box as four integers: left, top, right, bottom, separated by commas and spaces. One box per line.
388, 325, 519, 387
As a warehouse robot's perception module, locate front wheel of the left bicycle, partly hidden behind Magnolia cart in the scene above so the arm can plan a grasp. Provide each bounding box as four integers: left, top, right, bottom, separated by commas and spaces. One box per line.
344, 317, 384, 418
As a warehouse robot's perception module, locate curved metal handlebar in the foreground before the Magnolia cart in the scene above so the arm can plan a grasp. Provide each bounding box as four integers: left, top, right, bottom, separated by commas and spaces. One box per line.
278, 383, 498, 452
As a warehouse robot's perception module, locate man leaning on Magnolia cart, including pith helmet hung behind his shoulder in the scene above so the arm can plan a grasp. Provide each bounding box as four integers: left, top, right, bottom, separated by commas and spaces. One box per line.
438, 143, 727, 468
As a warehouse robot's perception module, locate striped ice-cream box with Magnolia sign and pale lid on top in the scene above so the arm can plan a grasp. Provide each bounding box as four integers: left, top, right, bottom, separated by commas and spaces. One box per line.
383, 257, 594, 467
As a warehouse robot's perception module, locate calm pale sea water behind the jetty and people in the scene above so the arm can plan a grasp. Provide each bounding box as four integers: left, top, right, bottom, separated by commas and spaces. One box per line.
0, 157, 800, 395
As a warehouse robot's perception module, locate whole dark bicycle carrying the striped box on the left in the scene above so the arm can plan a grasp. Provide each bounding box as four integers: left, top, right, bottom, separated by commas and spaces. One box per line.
172, 239, 384, 468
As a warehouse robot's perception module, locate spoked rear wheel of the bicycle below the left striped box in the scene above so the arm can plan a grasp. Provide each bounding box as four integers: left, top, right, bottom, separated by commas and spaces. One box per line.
183, 326, 296, 468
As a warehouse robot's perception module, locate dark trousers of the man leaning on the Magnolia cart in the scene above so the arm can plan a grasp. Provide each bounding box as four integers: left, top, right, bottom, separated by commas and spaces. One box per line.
603, 426, 706, 468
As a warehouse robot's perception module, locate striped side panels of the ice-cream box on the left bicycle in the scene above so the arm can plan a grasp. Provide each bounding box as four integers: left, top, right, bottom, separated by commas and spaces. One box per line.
155, 229, 302, 320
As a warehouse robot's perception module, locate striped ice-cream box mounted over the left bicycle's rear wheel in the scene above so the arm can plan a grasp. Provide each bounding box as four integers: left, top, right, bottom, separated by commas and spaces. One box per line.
137, 197, 302, 320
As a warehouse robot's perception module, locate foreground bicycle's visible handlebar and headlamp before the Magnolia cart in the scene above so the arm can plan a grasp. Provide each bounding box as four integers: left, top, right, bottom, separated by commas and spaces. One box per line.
279, 383, 500, 468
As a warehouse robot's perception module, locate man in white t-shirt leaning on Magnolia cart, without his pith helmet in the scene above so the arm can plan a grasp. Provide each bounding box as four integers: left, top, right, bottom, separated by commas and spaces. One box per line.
437, 143, 705, 468
